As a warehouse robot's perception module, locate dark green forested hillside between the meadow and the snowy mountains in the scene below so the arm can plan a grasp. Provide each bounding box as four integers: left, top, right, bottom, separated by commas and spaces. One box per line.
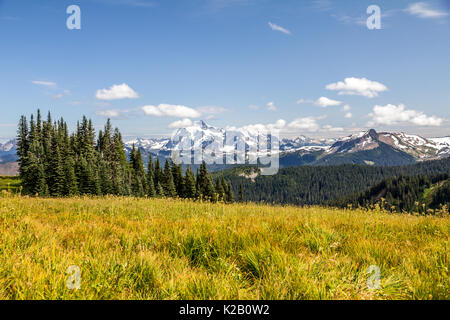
216, 158, 450, 205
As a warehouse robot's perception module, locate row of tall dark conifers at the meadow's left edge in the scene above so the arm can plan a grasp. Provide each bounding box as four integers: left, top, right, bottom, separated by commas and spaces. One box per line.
17, 110, 243, 203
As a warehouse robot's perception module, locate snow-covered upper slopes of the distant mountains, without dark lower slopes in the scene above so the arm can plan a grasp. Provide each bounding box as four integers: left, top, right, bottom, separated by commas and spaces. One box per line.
125, 121, 450, 163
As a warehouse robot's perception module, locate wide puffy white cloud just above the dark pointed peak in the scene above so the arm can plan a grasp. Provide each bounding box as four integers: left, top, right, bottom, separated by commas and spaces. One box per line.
368, 104, 444, 126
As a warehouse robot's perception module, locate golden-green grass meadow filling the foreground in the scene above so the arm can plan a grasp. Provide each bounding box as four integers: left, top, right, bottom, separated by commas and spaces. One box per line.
0, 191, 450, 300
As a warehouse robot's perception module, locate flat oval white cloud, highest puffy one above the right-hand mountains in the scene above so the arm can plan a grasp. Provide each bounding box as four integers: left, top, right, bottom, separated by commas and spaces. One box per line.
325, 78, 388, 98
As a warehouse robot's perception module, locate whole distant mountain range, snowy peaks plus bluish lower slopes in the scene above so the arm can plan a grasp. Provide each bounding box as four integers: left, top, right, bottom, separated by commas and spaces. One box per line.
0, 121, 450, 172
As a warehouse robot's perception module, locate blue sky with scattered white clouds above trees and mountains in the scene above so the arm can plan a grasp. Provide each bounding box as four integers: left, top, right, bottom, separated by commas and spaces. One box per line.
0, 0, 450, 140
